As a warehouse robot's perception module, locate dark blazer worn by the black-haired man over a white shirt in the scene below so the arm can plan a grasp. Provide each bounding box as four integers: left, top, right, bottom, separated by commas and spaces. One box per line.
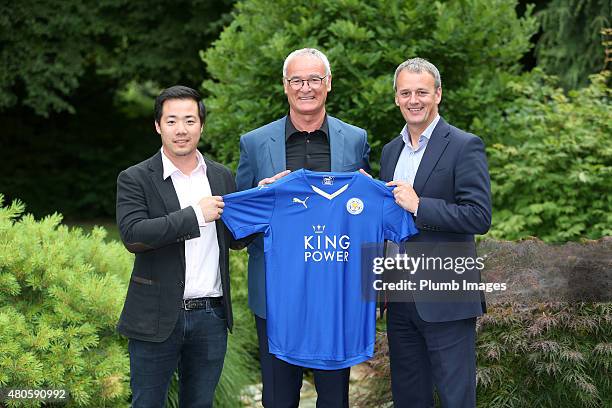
117, 152, 244, 342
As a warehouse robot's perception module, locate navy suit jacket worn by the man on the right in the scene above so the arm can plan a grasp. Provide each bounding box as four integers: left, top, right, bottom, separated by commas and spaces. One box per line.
380, 118, 491, 322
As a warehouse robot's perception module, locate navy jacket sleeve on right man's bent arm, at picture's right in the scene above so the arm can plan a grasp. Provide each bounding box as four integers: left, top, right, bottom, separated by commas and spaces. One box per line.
416, 137, 491, 234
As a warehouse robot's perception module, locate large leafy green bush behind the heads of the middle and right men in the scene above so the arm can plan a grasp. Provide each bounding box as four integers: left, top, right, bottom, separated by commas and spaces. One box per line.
204, 0, 536, 167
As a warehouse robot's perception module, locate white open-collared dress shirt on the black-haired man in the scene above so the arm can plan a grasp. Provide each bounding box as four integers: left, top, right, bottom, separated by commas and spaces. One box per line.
161, 148, 223, 299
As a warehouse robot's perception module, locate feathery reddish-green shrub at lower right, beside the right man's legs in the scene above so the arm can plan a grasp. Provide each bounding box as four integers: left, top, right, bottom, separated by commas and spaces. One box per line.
353, 238, 612, 408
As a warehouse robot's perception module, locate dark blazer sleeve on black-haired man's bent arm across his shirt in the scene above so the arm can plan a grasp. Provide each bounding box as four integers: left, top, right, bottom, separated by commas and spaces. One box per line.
117, 171, 200, 253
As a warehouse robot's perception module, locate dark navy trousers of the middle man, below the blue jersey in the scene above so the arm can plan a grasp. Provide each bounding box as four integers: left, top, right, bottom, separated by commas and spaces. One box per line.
255, 316, 351, 408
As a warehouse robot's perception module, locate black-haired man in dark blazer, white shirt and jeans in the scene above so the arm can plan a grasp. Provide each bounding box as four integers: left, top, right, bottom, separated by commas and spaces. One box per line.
117, 86, 240, 408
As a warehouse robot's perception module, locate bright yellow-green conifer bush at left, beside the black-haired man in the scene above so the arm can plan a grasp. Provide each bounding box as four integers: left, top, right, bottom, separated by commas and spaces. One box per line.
0, 196, 132, 407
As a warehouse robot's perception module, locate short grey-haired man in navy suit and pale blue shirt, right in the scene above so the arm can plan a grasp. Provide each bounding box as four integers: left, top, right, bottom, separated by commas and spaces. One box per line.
380, 58, 491, 408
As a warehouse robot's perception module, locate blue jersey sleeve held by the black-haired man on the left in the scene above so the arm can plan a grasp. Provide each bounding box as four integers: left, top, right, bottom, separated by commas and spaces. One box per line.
221, 187, 275, 239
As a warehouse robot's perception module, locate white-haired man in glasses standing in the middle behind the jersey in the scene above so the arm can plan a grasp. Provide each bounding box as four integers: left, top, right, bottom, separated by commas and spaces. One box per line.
236, 48, 370, 408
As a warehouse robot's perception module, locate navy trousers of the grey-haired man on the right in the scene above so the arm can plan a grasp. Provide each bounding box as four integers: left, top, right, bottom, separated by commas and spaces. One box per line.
387, 302, 476, 408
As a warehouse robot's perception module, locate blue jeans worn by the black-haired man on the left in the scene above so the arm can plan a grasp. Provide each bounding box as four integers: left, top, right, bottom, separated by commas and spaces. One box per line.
128, 304, 227, 408
